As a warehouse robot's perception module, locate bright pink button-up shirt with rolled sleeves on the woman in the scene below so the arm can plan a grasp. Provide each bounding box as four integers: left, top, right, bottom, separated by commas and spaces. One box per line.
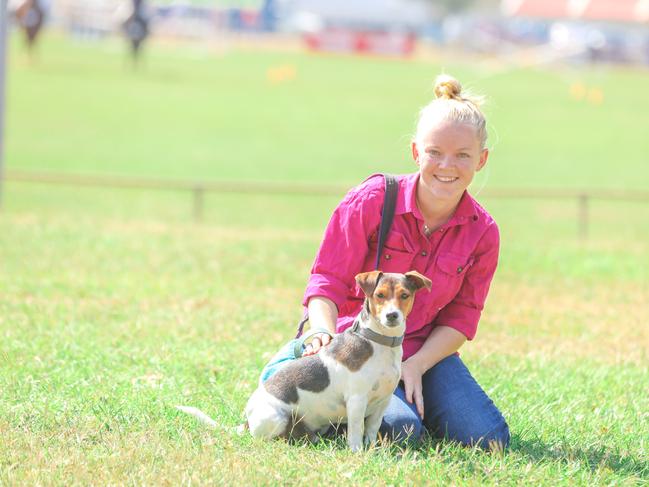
303, 173, 500, 360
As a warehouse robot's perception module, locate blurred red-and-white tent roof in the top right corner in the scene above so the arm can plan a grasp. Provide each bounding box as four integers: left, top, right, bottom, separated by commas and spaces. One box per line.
502, 0, 649, 23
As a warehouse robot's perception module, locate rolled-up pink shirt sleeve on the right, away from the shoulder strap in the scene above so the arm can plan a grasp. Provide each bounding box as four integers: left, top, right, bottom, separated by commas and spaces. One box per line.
435, 222, 500, 340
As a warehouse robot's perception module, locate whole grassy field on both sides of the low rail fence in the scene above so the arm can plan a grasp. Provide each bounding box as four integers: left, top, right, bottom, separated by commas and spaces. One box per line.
0, 36, 649, 486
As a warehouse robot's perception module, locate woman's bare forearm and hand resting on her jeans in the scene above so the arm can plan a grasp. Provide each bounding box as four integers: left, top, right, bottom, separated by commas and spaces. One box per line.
401, 325, 466, 419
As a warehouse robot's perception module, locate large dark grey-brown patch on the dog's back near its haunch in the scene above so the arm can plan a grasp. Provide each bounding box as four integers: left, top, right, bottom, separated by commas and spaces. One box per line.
264, 355, 330, 404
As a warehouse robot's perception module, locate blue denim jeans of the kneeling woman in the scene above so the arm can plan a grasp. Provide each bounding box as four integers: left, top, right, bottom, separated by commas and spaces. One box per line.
379, 355, 510, 448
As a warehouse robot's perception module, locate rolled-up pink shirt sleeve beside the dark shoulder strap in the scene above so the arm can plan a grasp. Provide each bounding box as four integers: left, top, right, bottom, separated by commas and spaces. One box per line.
302, 180, 385, 309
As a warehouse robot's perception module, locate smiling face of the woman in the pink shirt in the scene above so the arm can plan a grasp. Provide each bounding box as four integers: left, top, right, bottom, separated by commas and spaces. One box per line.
412, 120, 489, 204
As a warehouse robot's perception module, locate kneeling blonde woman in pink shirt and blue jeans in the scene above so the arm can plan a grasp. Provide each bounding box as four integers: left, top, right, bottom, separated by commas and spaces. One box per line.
304, 76, 510, 449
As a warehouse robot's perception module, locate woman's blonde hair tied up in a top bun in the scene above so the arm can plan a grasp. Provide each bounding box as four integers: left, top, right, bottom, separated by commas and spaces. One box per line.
415, 74, 487, 148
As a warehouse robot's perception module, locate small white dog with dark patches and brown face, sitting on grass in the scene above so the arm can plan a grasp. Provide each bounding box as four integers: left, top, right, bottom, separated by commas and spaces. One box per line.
245, 271, 431, 452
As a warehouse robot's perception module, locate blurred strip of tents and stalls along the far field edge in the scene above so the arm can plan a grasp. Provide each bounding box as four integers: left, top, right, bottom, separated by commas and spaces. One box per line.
9, 0, 649, 64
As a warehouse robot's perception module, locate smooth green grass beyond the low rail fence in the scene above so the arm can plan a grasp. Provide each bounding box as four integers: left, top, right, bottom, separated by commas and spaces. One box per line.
6, 31, 649, 189
